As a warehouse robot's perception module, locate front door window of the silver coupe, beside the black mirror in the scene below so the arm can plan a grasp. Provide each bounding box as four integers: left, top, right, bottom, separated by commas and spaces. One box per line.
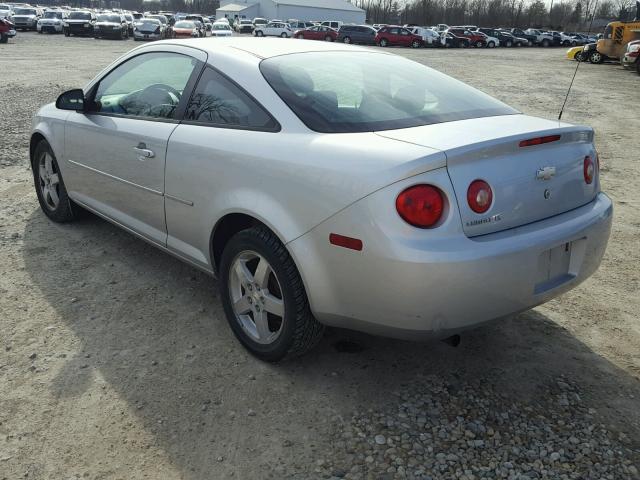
92, 52, 199, 119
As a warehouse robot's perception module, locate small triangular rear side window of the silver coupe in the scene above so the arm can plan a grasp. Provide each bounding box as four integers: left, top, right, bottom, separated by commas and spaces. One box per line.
185, 67, 279, 131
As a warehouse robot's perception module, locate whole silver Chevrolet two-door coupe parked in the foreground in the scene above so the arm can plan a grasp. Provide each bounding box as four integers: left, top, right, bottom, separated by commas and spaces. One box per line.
30, 38, 612, 361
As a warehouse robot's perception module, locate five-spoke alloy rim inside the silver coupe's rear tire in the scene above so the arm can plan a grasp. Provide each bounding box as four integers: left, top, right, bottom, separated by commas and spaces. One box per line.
229, 250, 285, 344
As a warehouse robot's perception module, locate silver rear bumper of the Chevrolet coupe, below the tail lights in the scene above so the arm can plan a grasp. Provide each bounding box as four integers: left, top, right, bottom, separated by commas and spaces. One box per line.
288, 188, 613, 340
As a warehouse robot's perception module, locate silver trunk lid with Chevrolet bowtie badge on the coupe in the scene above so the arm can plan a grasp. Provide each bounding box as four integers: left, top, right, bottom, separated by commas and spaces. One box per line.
378, 115, 599, 237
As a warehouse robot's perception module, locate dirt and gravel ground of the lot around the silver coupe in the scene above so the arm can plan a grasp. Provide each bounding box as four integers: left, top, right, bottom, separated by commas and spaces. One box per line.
0, 33, 640, 480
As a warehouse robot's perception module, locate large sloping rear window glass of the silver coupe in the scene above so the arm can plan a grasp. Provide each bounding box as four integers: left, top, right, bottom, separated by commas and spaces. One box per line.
260, 52, 518, 133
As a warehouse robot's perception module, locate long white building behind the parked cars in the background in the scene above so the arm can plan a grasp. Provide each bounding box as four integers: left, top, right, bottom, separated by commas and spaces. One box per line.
216, 0, 366, 23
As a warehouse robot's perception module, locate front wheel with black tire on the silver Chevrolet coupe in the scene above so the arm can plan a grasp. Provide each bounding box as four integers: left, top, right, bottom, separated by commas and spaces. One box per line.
31, 140, 80, 223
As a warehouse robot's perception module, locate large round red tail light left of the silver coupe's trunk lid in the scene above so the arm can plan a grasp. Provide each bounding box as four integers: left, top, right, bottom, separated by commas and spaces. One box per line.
396, 185, 444, 228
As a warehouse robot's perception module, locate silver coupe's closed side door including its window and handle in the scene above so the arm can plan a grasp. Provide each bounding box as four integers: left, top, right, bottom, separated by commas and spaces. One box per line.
65, 47, 206, 245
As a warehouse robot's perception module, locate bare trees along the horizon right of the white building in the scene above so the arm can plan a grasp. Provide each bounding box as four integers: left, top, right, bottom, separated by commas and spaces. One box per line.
353, 0, 635, 31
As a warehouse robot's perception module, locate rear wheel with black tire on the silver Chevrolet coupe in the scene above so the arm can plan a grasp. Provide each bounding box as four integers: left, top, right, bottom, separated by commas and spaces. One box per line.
220, 227, 324, 362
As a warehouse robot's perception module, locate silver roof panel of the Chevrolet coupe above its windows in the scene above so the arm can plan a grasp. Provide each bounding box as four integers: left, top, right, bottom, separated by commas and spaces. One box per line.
162, 37, 370, 58
